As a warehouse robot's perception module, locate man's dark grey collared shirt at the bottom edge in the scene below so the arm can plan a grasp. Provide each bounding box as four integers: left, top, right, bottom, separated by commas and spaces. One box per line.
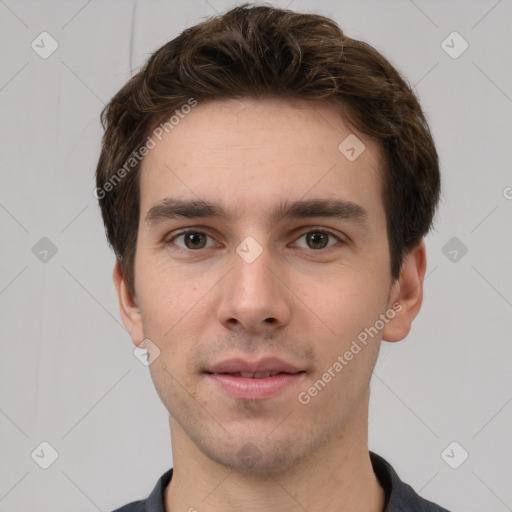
114, 452, 448, 512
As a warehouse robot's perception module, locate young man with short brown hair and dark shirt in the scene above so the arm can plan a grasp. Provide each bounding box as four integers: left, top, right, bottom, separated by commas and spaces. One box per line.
96, 5, 445, 512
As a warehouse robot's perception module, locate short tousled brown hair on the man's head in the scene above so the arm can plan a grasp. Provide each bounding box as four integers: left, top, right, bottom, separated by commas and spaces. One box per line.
95, 4, 440, 295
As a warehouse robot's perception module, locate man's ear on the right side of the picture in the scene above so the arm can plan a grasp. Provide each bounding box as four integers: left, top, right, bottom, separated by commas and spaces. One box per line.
382, 240, 427, 341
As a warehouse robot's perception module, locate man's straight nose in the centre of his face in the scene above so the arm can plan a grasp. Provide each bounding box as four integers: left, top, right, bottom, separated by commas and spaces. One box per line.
217, 245, 291, 334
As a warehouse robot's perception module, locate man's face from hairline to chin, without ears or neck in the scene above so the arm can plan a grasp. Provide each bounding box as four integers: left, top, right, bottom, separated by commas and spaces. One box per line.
123, 100, 396, 472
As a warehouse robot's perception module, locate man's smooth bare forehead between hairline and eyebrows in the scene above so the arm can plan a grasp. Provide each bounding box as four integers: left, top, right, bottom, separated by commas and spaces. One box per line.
136, 99, 384, 225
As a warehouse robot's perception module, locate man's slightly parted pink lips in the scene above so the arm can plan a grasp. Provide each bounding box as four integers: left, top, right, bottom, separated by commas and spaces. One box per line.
204, 358, 306, 400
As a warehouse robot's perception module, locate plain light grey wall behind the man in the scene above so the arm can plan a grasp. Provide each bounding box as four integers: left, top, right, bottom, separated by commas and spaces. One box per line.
0, 0, 512, 512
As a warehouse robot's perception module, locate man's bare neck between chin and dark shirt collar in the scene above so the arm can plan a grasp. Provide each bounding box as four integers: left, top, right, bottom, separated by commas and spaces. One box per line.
165, 402, 385, 512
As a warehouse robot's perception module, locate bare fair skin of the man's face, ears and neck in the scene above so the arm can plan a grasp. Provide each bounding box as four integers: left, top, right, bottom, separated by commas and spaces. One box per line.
114, 99, 426, 512
